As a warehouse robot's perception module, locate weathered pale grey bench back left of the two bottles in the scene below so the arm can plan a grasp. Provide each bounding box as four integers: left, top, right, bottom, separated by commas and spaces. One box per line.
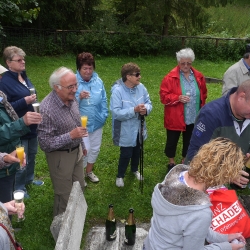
50, 181, 88, 250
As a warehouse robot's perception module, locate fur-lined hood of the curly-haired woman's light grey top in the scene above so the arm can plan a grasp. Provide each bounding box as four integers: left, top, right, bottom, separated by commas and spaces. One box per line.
151, 164, 211, 216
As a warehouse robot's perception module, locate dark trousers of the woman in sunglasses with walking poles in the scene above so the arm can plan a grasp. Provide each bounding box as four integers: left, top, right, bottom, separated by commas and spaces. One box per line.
117, 136, 140, 178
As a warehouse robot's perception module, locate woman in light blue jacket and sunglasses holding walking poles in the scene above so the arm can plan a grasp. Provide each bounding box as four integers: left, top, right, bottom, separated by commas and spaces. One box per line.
110, 63, 152, 187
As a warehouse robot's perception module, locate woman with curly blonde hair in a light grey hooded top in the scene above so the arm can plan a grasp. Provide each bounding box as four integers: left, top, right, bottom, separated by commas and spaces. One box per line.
143, 137, 245, 250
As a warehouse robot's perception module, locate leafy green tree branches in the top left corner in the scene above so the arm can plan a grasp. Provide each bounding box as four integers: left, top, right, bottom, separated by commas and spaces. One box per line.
0, 0, 40, 35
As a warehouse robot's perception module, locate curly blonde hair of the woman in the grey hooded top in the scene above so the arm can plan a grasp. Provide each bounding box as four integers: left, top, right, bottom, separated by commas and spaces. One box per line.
188, 137, 245, 187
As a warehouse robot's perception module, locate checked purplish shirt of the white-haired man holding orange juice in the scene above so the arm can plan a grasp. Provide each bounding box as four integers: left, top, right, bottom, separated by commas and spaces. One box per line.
37, 90, 84, 152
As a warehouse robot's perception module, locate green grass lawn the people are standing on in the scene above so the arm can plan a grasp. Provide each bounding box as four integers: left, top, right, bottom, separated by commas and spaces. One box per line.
10, 55, 246, 250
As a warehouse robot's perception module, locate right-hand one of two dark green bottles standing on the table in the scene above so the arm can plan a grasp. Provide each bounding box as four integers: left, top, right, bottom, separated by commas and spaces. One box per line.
124, 208, 136, 246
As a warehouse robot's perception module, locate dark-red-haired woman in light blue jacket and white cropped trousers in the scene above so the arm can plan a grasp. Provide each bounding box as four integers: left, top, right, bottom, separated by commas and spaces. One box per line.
76, 52, 108, 182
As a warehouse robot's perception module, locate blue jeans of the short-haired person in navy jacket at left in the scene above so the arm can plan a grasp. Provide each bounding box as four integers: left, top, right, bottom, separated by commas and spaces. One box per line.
15, 137, 38, 192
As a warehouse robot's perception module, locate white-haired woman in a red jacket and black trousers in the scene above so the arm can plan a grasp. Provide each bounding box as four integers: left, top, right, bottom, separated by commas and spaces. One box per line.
160, 48, 207, 170
